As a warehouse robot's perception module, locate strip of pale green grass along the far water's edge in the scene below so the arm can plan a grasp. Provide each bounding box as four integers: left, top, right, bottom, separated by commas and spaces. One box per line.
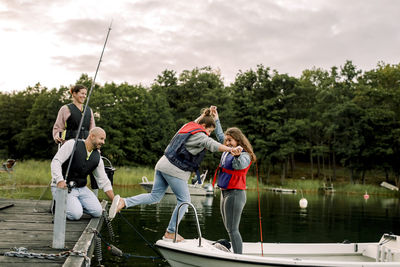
0, 160, 400, 196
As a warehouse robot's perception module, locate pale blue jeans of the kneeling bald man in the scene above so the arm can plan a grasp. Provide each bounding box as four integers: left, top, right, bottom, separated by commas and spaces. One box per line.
51, 186, 103, 221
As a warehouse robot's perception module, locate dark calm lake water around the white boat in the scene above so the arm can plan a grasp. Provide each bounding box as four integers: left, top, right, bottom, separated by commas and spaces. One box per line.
98, 189, 400, 266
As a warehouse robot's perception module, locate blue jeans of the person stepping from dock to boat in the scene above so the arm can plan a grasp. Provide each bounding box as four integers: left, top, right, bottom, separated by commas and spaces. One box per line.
124, 170, 190, 233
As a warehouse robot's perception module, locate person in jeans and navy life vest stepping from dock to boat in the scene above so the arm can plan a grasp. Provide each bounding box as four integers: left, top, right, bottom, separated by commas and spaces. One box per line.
109, 108, 242, 242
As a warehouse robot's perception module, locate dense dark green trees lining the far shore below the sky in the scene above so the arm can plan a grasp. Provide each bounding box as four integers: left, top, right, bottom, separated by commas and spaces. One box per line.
0, 61, 400, 185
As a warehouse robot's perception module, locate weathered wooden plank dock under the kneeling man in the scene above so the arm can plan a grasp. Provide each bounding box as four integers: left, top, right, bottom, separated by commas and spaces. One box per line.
0, 198, 107, 267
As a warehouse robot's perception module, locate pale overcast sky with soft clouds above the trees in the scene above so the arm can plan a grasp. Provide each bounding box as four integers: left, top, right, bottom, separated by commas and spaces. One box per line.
0, 0, 400, 92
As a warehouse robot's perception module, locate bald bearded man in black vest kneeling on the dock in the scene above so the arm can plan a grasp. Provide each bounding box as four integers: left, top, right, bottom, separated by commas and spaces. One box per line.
51, 127, 114, 220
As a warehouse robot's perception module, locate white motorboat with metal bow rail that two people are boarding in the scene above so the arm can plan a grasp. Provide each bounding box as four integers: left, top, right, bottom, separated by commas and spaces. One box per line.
156, 203, 400, 267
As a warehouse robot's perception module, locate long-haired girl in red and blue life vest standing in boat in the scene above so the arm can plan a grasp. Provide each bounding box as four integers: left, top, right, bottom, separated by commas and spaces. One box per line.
211, 107, 256, 254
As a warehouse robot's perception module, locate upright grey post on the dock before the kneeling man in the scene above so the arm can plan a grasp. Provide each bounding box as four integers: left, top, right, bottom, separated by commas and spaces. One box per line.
53, 188, 68, 248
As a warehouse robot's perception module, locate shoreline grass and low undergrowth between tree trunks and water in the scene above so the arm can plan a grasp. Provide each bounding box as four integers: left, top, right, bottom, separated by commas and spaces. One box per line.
0, 160, 400, 197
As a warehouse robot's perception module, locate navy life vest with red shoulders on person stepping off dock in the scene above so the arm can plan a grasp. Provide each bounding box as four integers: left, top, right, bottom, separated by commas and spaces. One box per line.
164, 121, 208, 184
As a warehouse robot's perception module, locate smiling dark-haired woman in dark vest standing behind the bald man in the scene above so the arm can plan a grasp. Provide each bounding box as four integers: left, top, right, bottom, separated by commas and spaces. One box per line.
53, 84, 96, 144
